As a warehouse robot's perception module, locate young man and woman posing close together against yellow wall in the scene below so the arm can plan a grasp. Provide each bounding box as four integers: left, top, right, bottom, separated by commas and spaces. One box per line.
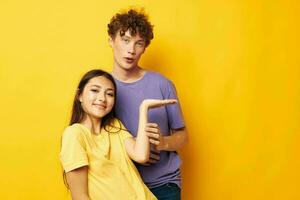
60, 10, 187, 200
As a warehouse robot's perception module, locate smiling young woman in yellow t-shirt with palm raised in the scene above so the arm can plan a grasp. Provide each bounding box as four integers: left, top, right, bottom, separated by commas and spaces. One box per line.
60, 70, 176, 200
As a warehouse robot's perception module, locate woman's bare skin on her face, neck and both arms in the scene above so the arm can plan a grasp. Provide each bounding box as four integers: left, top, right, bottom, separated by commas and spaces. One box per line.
66, 76, 177, 200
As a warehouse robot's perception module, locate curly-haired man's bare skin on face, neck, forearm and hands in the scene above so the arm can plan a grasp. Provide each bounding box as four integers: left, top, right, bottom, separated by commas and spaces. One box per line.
109, 30, 188, 165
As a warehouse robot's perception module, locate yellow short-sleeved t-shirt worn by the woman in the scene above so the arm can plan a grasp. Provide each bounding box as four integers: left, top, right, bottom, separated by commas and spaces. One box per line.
60, 120, 156, 200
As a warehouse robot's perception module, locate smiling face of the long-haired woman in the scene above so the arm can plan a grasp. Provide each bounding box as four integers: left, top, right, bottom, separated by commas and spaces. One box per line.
79, 76, 115, 119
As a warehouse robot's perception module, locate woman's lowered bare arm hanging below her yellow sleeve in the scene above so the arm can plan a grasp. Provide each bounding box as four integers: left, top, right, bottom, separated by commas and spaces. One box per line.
66, 166, 90, 200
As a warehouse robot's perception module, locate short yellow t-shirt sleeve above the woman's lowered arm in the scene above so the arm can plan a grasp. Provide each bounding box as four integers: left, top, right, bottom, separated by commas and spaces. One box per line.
60, 126, 89, 172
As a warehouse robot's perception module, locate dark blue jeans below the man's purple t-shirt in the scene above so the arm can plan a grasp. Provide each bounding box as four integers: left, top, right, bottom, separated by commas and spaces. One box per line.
150, 183, 181, 200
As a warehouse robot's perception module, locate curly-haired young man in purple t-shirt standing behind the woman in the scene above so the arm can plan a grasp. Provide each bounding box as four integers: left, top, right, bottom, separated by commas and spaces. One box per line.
108, 9, 187, 200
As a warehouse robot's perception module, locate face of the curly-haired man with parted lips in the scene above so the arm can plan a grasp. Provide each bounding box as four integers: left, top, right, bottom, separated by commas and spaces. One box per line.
109, 30, 146, 70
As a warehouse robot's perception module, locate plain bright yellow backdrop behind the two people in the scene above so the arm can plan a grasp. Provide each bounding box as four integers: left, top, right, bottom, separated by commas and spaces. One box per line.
0, 0, 300, 200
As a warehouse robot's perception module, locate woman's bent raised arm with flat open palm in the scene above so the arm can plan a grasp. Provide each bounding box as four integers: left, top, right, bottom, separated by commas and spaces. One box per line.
125, 99, 177, 163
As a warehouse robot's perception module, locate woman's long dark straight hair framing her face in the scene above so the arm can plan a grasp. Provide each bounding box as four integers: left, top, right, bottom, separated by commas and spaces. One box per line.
69, 69, 117, 128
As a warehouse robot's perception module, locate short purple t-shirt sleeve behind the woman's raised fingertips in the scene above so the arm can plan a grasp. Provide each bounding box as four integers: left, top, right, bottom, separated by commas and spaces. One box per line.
164, 80, 185, 129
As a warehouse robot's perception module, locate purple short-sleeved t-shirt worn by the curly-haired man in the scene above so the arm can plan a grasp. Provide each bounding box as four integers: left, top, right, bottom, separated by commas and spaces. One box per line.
115, 71, 185, 188
